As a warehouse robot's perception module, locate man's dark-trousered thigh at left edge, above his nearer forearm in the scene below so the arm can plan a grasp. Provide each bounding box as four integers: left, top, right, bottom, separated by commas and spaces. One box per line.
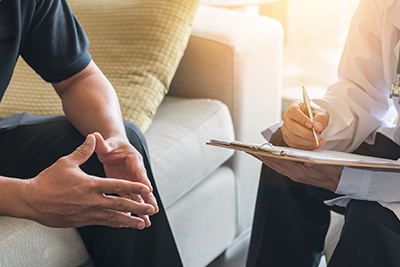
0, 113, 86, 179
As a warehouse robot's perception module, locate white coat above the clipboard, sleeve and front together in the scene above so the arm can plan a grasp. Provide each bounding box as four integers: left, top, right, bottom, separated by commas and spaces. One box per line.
314, 0, 400, 152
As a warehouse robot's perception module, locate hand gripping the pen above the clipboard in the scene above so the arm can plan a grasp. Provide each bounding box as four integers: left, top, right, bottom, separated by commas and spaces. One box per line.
281, 100, 329, 150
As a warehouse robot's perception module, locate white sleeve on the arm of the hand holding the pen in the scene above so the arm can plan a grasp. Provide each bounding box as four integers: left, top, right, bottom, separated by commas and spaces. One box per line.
313, 0, 392, 152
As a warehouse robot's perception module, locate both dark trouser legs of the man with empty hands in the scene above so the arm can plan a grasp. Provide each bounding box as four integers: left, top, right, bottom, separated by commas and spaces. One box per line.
0, 113, 182, 267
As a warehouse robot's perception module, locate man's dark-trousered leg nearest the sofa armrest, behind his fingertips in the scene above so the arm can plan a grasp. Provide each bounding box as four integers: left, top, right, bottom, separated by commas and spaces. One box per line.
78, 121, 182, 267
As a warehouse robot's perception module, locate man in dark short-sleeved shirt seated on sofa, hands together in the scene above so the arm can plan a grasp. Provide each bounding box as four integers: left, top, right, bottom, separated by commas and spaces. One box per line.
0, 0, 182, 266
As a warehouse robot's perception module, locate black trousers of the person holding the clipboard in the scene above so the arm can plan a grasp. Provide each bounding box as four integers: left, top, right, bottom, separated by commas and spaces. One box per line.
247, 131, 400, 267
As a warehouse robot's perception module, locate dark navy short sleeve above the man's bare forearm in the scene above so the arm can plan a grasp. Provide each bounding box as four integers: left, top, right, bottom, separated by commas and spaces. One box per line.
21, 0, 91, 82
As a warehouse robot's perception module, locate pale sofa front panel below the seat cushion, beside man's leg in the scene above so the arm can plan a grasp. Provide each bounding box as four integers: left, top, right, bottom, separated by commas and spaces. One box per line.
167, 166, 237, 266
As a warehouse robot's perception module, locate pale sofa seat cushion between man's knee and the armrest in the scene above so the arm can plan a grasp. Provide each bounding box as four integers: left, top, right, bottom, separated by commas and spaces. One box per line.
146, 96, 234, 208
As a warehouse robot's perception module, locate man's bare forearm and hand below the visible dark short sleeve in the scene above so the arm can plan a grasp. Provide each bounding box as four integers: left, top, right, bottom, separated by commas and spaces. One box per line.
53, 62, 158, 227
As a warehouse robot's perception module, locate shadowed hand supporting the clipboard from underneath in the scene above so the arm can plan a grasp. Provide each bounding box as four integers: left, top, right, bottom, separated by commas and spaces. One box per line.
251, 154, 343, 192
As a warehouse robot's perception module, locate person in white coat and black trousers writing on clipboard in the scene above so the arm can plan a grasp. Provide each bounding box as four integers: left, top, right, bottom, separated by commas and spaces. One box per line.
247, 0, 400, 267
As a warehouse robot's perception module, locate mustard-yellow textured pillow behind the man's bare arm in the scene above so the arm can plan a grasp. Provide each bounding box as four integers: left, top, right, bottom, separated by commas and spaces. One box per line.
0, 0, 200, 131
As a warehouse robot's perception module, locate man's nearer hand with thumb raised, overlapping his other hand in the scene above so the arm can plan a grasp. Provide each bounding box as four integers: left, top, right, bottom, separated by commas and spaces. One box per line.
21, 135, 156, 229
